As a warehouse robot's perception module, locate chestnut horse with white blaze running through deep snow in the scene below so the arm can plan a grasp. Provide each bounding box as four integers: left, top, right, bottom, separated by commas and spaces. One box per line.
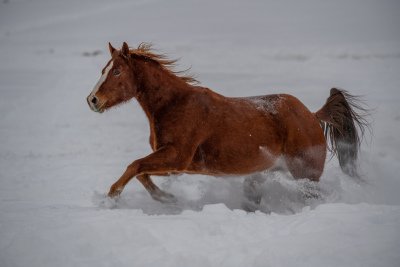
87, 42, 367, 202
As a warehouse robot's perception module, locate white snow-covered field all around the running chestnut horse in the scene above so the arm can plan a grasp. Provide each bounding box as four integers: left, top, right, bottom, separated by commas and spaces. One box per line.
0, 0, 400, 267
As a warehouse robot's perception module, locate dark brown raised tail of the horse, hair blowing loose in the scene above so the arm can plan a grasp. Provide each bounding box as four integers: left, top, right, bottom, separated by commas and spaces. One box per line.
315, 88, 370, 177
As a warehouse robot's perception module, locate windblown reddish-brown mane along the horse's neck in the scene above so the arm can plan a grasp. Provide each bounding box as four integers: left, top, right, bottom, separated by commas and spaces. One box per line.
129, 43, 199, 85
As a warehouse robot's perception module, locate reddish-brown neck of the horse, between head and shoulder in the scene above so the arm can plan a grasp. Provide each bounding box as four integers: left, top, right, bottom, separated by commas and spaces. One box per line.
137, 62, 190, 121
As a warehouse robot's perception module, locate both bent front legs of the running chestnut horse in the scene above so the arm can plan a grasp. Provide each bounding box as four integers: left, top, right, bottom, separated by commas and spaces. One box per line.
108, 146, 192, 200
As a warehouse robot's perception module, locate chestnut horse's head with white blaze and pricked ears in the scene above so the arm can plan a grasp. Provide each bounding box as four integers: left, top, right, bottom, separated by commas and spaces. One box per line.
87, 42, 136, 113
